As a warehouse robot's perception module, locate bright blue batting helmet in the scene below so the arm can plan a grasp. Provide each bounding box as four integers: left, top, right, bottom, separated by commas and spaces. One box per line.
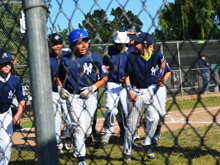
68, 29, 90, 51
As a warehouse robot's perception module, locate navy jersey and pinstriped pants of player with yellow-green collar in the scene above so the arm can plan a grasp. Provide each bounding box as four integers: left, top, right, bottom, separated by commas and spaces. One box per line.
123, 50, 165, 155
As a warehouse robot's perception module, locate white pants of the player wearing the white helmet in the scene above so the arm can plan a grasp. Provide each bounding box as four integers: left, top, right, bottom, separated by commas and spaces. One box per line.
103, 82, 127, 135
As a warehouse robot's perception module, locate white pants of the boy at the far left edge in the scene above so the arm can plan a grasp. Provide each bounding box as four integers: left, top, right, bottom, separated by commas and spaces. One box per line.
0, 108, 13, 165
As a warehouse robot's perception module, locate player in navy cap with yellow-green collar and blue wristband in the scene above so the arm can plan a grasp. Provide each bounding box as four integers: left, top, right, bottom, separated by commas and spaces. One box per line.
123, 32, 166, 163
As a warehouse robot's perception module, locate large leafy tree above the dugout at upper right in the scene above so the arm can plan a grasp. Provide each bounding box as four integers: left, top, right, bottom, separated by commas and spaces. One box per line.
153, 0, 220, 41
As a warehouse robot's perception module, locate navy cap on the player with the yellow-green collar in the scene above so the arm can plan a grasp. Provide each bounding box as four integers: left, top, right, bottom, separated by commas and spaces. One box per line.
129, 32, 156, 46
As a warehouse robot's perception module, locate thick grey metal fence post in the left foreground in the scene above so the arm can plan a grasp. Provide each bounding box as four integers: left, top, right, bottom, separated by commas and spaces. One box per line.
23, 0, 58, 165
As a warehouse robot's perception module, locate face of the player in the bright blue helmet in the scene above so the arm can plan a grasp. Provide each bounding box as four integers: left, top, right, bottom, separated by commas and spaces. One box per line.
75, 38, 89, 57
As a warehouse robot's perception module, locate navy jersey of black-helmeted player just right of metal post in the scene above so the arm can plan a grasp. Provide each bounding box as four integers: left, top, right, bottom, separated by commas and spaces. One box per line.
50, 50, 69, 92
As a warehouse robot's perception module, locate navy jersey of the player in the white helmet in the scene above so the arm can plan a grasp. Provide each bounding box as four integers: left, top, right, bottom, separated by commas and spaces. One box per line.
103, 46, 127, 82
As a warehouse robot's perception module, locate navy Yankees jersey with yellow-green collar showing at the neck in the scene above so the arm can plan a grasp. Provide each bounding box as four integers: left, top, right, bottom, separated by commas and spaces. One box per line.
125, 51, 165, 88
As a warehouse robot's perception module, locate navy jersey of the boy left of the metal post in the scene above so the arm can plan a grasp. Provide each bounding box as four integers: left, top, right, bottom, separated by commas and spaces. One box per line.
0, 74, 26, 113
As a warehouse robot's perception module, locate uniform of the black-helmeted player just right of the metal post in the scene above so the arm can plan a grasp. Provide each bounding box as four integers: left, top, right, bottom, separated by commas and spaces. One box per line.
50, 50, 70, 151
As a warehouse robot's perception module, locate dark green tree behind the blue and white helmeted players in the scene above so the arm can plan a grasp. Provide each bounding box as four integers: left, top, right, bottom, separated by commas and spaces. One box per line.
79, 7, 143, 43
